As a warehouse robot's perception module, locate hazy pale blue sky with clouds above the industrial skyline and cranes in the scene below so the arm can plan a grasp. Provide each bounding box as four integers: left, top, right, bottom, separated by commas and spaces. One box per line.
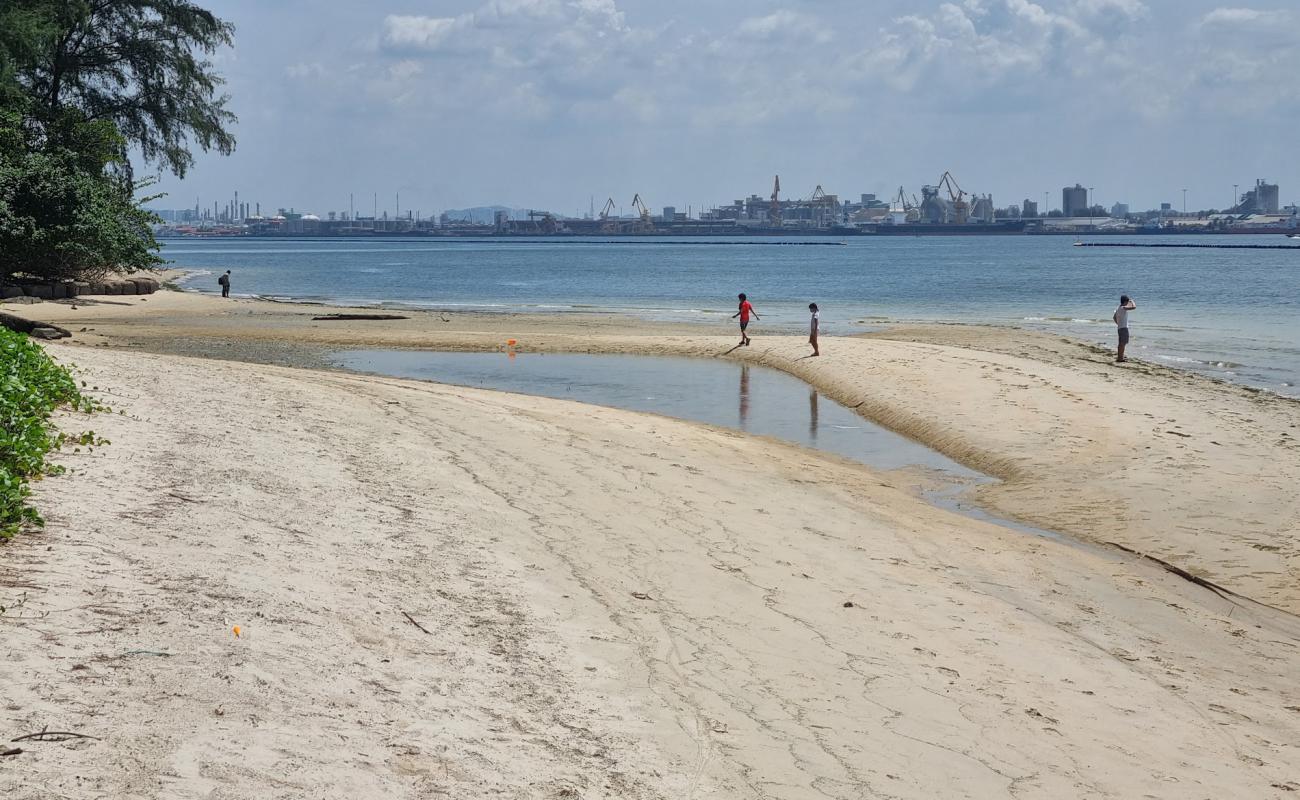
159, 0, 1300, 215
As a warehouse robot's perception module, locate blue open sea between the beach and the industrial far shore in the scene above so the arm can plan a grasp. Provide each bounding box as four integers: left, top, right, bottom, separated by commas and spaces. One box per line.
163, 235, 1300, 397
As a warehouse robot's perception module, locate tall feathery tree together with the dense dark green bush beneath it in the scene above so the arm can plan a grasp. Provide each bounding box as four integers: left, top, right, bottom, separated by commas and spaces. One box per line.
0, 0, 235, 281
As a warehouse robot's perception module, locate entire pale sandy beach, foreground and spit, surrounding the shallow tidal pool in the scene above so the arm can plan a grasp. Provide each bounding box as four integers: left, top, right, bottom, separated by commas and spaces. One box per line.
0, 293, 1300, 799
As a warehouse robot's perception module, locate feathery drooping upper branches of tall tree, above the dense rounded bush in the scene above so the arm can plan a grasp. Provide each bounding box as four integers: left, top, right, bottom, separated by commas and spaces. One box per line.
0, 0, 235, 177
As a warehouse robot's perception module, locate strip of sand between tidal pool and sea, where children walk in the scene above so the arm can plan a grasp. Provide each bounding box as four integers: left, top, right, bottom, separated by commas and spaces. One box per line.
16, 291, 1300, 613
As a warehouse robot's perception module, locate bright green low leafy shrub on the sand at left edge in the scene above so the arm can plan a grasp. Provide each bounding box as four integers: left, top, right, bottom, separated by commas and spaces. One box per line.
0, 329, 95, 540
